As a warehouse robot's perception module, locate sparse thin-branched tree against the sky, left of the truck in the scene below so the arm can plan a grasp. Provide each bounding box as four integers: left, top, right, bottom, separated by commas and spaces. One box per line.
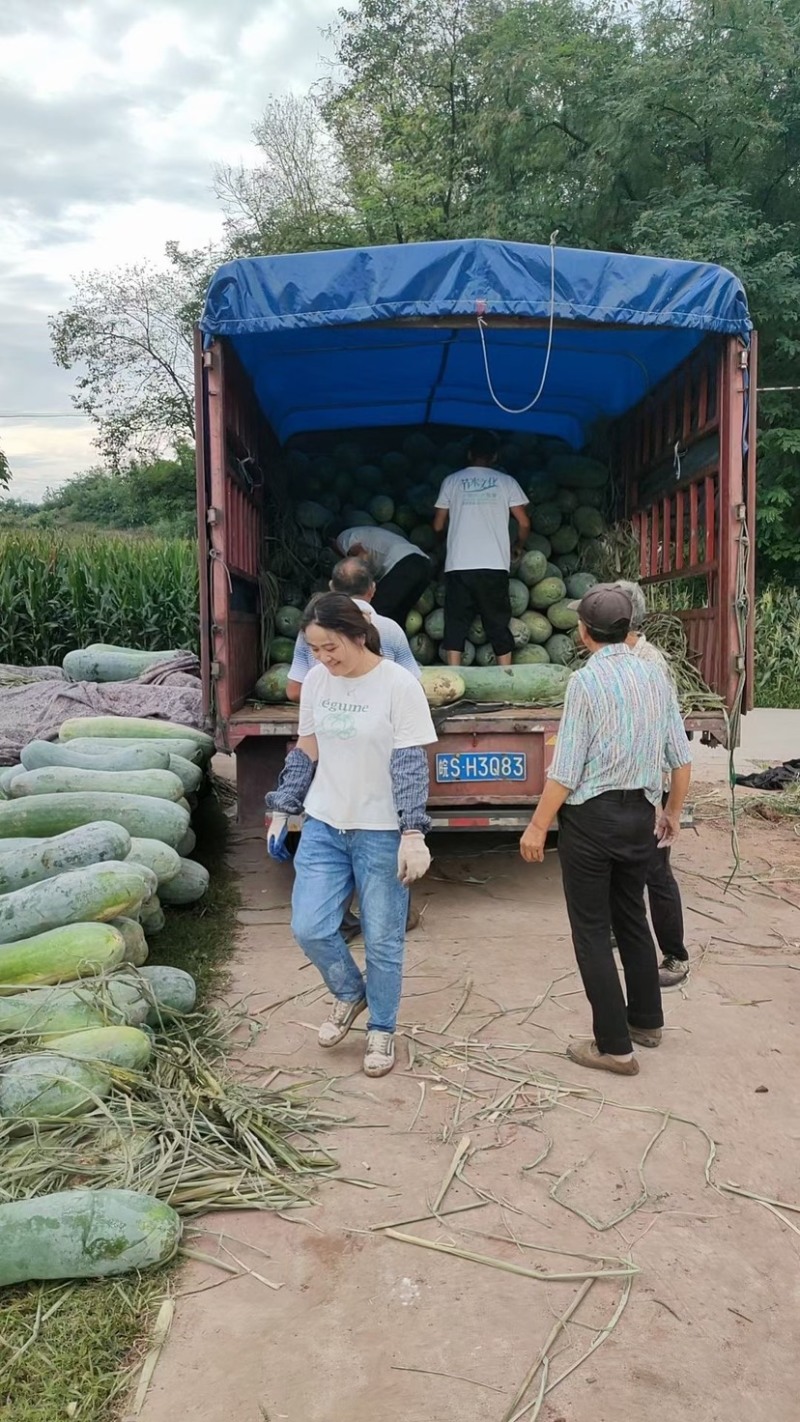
50, 262, 195, 469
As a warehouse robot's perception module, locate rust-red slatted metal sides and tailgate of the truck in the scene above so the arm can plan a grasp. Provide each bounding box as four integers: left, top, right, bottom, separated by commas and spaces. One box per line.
196, 285, 756, 830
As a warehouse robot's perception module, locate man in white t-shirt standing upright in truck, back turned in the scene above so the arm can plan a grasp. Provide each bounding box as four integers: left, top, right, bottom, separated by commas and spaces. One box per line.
433, 429, 530, 667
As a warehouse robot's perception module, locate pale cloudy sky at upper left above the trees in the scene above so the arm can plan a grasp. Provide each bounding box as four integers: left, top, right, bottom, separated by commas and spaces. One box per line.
0, 0, 338, 499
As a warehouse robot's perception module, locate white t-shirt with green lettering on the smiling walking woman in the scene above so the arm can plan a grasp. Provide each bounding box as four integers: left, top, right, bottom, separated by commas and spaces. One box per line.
300, 658, 436, 829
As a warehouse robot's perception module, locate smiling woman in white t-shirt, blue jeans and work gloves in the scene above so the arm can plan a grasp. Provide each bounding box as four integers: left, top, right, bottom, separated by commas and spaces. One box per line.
266, 593, 436, 1076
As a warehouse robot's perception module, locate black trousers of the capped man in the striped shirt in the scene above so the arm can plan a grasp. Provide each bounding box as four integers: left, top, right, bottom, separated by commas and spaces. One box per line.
558, 791, 664, 1057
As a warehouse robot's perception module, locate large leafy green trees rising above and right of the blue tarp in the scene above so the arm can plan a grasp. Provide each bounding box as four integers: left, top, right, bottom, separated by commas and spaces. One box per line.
314, 0, 800, 580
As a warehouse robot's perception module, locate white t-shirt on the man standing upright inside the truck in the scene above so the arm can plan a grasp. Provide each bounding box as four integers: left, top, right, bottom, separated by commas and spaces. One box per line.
436, 468, 527, 573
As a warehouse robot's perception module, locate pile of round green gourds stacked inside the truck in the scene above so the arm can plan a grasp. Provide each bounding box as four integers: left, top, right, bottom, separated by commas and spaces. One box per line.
254, 428, 611, 702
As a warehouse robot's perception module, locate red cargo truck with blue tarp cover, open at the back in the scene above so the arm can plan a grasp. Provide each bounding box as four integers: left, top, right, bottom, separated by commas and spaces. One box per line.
195, 239, 757, 828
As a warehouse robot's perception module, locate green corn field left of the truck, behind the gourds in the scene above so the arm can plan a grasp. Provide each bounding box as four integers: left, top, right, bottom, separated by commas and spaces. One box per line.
0, 530, 199, 667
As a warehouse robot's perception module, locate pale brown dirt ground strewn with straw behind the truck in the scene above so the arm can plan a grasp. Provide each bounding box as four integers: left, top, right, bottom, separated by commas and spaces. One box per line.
142, 762, 800, 1422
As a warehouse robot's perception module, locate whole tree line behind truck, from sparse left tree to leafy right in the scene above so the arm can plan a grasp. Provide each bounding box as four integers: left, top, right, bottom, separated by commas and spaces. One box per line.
54, 0, 800, 579
